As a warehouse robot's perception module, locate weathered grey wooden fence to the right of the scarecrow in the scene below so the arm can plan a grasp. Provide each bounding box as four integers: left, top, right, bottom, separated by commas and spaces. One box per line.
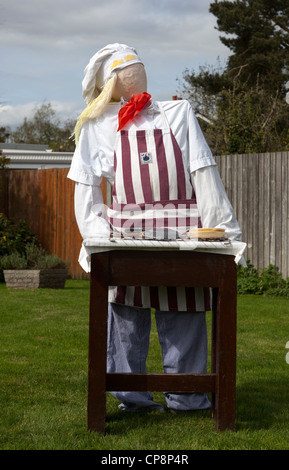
216, 152, 289, 277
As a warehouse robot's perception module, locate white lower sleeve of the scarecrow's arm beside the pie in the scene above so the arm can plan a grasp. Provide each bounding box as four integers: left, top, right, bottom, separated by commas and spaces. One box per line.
191, 166, 242, 240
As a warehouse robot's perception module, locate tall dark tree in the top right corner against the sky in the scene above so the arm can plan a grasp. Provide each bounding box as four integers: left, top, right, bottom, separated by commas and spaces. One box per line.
209, 0, 289, 91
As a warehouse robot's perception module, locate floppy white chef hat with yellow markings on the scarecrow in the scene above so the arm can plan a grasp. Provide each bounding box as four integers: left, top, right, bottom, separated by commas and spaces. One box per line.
82, 43, 142, 104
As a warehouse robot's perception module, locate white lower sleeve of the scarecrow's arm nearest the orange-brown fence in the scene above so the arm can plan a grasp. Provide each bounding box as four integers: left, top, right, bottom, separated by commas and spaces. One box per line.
74, 182, 110, 239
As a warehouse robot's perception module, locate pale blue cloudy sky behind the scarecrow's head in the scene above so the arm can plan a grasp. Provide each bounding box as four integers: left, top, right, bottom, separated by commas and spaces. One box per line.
0, 0, 229, 130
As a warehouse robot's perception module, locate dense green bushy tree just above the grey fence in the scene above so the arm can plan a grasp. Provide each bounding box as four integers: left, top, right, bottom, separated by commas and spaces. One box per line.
206, 80, 289, 154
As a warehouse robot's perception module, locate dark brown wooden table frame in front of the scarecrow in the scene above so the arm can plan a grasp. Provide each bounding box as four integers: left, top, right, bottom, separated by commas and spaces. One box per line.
87, 249, 237, 434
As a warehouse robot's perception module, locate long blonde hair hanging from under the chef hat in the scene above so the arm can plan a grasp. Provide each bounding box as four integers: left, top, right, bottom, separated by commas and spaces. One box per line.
71, 73, 117, 146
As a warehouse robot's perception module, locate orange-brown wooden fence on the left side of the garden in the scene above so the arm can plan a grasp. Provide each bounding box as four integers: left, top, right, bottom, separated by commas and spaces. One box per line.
0, 168, 106, 279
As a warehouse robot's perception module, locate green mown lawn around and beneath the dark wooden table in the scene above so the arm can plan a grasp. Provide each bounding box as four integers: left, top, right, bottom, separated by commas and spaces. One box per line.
0, 280, 289, 450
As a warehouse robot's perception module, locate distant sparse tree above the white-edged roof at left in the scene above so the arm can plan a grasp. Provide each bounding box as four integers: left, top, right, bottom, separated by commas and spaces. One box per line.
11, 103, 75, 151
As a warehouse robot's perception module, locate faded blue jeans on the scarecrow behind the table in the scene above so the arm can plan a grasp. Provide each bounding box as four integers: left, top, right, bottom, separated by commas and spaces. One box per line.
107, 303, 210, 411
